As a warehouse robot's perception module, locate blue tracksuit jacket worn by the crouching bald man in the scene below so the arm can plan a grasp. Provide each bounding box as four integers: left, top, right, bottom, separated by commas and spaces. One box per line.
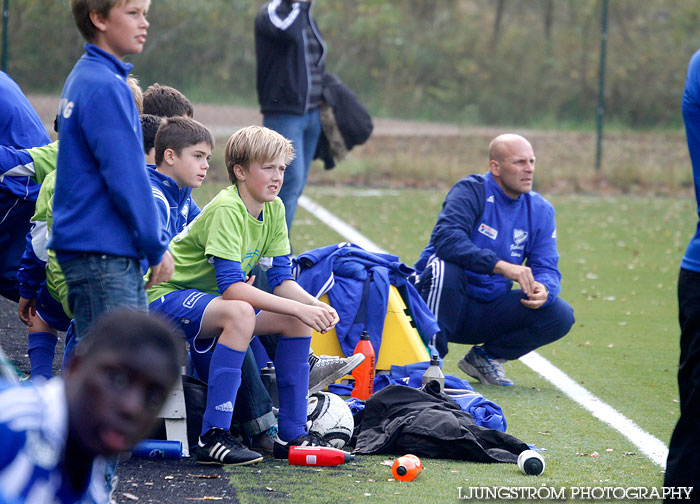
415, 173, 561, 306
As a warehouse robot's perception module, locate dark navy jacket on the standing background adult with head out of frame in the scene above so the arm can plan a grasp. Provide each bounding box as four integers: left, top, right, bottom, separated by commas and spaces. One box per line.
255, 0, 326, 115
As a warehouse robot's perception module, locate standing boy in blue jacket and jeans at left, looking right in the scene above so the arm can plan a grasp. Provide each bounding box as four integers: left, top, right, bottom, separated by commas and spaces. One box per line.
49, 0, 172, 341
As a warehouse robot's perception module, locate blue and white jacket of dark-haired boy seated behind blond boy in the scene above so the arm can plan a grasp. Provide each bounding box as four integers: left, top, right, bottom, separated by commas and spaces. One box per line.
141, 165, 201, 272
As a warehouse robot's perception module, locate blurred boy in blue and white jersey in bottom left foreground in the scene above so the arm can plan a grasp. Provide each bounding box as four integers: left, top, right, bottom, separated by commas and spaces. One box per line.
0, 310, 183, 504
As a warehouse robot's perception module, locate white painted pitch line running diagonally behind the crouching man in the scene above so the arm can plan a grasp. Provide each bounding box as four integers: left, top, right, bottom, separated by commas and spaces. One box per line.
298, 196, 668, 469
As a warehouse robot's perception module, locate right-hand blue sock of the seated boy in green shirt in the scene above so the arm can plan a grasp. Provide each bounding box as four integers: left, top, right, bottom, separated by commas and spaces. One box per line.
275, 337, 311, 441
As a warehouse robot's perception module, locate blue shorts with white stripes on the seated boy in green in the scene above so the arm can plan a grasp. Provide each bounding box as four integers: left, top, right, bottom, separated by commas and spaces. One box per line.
149, 289, 218, 353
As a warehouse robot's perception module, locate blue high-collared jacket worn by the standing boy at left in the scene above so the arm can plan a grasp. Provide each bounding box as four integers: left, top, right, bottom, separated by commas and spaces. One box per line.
49, 44, 168, 265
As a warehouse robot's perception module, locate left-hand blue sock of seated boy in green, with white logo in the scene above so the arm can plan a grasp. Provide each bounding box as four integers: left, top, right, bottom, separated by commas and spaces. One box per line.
200, 343, 246, 434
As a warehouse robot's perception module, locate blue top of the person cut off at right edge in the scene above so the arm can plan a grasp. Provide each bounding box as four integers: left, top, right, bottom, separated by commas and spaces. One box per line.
681, 51, 700, 273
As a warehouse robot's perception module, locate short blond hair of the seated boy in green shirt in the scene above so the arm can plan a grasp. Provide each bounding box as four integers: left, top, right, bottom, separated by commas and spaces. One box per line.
224, 126, 294, 184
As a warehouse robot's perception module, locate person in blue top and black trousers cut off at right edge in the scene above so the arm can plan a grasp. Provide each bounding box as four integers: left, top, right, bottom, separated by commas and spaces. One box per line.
664, 51, 700, 502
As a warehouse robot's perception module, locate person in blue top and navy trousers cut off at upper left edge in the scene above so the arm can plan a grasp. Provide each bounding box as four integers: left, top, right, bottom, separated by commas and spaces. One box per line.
0, 72, 51, 301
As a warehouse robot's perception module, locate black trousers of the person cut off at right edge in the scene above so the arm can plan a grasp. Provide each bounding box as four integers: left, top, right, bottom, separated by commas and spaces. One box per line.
664, 269, 700, 502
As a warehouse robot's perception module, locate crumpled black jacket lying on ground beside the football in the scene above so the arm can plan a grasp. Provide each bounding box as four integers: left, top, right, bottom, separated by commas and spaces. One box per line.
355, 382, 529, 463
